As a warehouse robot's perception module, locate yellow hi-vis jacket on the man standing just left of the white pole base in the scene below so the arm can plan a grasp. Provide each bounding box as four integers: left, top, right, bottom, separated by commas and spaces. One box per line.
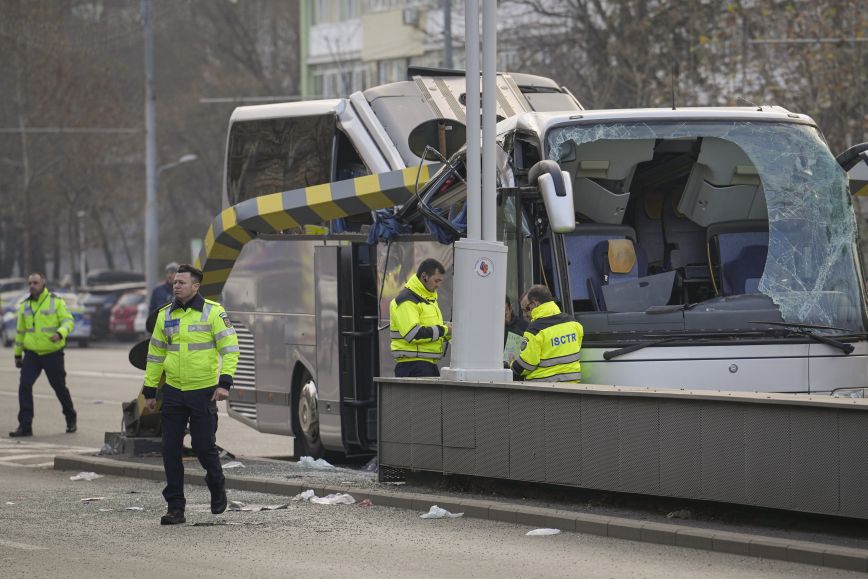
389, 275, 450, 364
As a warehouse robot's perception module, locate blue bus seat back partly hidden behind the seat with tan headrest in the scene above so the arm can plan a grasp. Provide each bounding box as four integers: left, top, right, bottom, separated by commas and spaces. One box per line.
564, 223, 636, 309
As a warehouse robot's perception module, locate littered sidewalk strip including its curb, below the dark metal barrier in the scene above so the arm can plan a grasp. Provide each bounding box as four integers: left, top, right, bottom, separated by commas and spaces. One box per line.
54, 455, 868, 572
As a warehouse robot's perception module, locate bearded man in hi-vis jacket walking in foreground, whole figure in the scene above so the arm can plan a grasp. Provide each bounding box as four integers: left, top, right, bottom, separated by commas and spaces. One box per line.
144, 264, 239, 525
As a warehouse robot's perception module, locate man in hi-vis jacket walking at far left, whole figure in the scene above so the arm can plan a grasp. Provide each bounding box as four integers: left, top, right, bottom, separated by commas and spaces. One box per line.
9, 273, 77, 437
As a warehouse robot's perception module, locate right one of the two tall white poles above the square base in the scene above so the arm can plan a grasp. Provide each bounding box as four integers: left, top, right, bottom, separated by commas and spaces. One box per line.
482, 0, 497, 241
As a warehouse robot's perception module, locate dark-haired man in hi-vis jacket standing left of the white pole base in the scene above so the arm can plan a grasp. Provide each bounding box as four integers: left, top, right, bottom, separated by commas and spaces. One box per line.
389, 258, 452, 378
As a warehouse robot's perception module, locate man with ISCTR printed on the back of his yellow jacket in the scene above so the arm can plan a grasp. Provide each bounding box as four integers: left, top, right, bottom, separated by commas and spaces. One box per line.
512, 285, 584, 382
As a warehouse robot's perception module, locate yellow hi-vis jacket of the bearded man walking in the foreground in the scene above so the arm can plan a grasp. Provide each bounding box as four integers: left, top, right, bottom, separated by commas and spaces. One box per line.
145, 294, 240, 390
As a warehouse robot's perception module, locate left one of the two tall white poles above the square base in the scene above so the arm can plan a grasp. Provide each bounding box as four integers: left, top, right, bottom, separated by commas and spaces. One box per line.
464, 0, 482, 239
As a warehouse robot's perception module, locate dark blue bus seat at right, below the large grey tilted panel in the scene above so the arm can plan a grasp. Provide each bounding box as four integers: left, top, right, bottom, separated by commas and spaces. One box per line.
707, 220, 769, 296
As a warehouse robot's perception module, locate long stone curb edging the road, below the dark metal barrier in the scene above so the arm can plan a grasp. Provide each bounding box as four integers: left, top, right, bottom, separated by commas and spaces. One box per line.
54, 455, 868, 573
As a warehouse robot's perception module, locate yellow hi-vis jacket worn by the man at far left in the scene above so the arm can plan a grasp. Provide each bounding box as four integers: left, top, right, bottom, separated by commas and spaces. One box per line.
15, 288, 75, 356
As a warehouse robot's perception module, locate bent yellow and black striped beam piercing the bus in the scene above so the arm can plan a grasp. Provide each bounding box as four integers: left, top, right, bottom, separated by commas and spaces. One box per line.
196, 164, 440, 299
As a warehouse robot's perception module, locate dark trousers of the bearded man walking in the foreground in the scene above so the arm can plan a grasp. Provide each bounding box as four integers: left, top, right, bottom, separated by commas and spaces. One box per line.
161, 384, 225, 511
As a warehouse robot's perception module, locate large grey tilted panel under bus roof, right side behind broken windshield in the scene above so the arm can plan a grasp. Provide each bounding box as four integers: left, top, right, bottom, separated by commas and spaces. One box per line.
676, 137, 768, 227
